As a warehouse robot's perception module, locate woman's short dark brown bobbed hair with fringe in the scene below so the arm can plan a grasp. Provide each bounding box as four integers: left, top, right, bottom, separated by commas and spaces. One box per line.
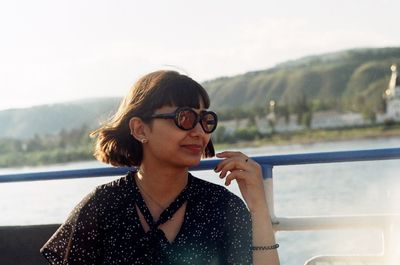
90, 70, 215, 166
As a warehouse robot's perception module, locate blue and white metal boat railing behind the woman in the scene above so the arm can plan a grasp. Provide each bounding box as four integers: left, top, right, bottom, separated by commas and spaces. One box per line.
0, 148, 400, 265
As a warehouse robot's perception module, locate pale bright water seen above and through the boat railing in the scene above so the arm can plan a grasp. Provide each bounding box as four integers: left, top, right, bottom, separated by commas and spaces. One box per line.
0, 137, 400, 265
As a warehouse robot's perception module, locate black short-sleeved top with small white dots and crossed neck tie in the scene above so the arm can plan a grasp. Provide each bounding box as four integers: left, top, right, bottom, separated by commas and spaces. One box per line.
40, 172, 252, 265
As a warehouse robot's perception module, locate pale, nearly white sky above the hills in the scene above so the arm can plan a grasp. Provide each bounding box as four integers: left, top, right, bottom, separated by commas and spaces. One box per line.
0, 0, 400, 110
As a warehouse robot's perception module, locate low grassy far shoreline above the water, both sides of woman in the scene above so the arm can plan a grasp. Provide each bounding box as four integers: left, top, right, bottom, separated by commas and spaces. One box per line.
0, 123, 400, 169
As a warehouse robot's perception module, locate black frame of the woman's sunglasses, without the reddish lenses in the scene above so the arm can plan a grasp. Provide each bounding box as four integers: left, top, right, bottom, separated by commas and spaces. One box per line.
150, 107, 218, 133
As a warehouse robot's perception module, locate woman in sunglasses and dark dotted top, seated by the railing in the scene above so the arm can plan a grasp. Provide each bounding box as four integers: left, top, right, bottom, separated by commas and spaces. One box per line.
41, 71, 279, 264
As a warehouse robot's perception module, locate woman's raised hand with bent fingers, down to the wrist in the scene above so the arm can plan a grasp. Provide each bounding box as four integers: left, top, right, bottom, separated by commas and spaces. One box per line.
214, 151, 267, 212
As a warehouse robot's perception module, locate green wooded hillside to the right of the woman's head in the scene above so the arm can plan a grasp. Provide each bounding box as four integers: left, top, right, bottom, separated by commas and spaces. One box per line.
204, 47, 400, 111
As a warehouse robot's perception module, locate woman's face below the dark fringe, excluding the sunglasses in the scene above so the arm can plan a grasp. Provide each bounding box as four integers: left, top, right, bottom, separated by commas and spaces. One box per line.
143, 104, 211, 167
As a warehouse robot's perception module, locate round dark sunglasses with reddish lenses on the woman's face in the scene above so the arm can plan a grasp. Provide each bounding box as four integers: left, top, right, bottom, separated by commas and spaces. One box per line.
151, 107, 218, 133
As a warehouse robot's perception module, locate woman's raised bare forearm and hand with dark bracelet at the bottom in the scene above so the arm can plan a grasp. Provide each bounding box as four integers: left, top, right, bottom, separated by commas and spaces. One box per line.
215, 152, 279, 265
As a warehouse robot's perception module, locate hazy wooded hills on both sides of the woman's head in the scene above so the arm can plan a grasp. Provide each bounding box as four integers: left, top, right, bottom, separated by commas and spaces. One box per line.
0, 47, 400, 139
